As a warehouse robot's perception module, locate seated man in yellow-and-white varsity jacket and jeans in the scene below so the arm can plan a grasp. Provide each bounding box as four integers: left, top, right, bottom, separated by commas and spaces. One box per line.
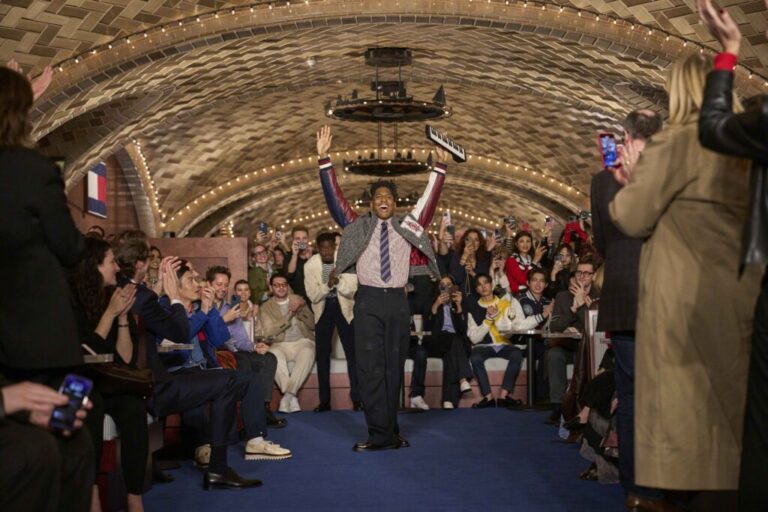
467, 274, 523, 409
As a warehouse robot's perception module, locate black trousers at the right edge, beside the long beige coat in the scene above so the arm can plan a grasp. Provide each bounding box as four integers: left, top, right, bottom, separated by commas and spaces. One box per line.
739, 276, 768, 512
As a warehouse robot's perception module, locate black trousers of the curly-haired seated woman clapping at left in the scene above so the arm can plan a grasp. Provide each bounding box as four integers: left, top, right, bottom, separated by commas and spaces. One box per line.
85, 389, 149, 494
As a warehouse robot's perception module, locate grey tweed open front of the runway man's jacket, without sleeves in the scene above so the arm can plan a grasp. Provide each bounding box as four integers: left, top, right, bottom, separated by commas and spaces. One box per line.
336, 212, 440, 279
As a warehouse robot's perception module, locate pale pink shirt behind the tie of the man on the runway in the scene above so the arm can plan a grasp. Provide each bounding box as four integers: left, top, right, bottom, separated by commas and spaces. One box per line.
357, 217, 411, 288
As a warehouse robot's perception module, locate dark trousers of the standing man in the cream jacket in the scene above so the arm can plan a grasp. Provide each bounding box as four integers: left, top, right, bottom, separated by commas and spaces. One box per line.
315, 298, 360, 403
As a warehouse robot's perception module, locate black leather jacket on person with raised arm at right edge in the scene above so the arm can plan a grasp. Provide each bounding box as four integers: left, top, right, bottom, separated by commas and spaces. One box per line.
699, 71, 768, 267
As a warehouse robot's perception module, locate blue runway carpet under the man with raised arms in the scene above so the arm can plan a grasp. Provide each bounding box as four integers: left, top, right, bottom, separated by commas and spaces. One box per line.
144, 409, 624, 512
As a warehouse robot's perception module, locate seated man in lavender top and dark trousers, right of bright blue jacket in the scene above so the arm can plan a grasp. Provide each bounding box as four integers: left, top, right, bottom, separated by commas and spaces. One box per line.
205, 266, 286, 428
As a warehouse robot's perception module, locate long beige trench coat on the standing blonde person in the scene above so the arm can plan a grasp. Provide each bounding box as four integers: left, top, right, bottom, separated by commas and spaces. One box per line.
610, 122, 762, 490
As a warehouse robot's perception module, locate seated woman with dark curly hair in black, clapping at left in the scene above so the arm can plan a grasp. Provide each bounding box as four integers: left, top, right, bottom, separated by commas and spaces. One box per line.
69, 237, 149, 512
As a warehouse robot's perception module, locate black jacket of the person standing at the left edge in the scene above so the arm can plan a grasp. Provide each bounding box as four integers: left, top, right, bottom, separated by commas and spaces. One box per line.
0, 149, 83, 369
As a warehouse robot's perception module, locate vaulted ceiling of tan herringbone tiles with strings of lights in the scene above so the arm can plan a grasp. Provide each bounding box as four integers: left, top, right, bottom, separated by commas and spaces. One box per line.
0, 0, 768, 240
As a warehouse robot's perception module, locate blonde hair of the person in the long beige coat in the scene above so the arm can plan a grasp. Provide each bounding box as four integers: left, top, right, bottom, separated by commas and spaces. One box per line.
666, 53, 743, 125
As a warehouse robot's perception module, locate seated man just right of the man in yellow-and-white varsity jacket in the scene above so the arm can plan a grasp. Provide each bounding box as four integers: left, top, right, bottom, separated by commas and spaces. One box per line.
516, 269, 555, 398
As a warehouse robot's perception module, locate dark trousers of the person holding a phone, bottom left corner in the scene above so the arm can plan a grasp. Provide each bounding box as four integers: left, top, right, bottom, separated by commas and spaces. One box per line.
0, 421, 95, 512
